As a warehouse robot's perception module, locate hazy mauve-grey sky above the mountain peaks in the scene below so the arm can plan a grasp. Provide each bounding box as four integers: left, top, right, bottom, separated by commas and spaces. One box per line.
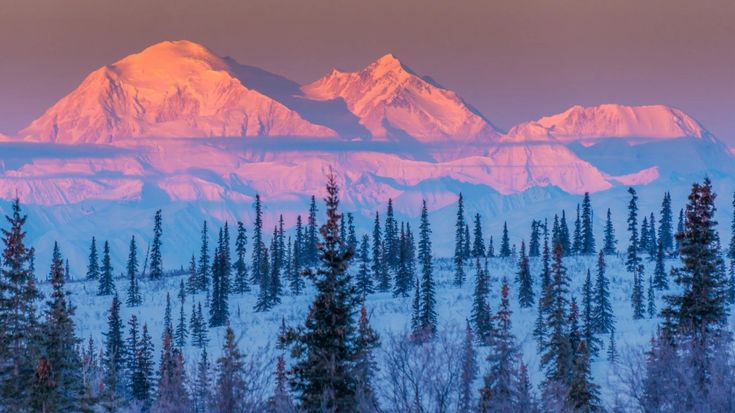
0, 0, 735, 144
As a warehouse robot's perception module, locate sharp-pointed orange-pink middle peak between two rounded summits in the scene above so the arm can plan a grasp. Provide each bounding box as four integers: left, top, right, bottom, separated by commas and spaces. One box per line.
302, 54, 499, 142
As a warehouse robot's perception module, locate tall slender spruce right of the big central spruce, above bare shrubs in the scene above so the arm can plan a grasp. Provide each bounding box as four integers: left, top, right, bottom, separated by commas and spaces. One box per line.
419, 200, 437, 337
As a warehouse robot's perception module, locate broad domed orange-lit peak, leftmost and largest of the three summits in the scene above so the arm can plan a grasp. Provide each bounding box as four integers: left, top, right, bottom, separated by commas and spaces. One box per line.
20, 41, 336, 143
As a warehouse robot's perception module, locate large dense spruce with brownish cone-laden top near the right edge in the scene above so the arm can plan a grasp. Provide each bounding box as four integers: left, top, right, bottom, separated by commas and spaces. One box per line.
661, 178, 728, 388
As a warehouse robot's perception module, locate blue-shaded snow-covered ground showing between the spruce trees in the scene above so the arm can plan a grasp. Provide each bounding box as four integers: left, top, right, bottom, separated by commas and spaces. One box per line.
43, 251, 712, 403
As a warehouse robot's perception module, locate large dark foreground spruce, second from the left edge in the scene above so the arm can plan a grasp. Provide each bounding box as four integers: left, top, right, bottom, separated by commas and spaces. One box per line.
31, 243, 84, 412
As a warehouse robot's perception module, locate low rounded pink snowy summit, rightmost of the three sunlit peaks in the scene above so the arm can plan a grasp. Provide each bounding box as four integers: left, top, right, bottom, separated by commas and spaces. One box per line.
508, 104, 715, 144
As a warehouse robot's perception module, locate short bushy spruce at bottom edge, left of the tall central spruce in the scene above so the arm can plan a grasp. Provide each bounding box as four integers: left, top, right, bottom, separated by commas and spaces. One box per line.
212, 327, 247, 413
